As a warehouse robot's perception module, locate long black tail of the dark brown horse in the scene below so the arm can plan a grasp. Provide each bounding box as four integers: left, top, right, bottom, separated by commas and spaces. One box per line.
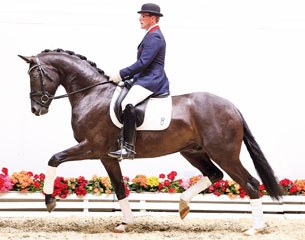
240, 110, 283, 200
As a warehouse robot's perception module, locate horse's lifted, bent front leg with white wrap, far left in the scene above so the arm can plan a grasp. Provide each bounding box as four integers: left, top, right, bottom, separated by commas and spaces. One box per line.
43, 141, 94, 212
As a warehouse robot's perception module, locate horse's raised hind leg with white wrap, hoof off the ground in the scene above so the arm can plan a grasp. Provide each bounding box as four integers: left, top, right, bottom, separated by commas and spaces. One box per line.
179, 151, 223, 219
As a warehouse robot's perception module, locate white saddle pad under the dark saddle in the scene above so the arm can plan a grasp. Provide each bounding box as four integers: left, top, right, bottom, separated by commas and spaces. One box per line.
110, 86, 172, 131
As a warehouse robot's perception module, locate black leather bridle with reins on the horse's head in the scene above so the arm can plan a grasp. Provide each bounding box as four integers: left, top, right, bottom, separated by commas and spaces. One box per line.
28, 56, 112, 108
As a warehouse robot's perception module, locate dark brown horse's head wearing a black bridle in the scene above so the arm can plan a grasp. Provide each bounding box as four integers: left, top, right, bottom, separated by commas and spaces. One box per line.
18, 55, 59, 116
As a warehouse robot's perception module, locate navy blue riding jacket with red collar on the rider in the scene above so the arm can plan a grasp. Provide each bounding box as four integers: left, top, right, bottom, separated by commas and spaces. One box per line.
120, 26, 169, 95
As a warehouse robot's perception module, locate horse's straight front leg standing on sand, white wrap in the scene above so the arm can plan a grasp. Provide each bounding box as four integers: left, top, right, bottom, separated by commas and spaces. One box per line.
101, 158, 133, 233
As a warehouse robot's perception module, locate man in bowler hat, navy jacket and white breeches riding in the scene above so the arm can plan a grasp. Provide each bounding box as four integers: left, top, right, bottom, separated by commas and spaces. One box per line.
108, 3, 169, 159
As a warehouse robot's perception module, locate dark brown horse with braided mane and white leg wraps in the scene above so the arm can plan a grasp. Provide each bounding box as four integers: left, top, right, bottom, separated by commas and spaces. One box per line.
18, 49, 282, 235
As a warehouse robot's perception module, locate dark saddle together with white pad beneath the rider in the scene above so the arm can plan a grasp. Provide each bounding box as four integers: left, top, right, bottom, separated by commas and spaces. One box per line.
110, 80, 171, 130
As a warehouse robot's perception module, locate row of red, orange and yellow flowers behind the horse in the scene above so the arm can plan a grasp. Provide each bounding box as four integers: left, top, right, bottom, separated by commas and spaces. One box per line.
0, 168, 305, 198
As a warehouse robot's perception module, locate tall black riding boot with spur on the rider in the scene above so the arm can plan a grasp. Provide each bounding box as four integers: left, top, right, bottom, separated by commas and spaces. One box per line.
108, 104, 136, 159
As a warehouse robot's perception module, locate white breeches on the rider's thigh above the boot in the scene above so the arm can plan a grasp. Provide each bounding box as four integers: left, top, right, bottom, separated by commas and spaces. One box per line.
122, 85, 153, 111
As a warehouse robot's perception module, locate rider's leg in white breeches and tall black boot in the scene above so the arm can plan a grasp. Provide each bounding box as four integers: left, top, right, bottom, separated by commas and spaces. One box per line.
108, 85, 153, 159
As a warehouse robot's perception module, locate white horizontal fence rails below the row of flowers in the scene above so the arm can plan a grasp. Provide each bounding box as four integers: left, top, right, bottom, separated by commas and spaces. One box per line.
0, 192, 305, 216
